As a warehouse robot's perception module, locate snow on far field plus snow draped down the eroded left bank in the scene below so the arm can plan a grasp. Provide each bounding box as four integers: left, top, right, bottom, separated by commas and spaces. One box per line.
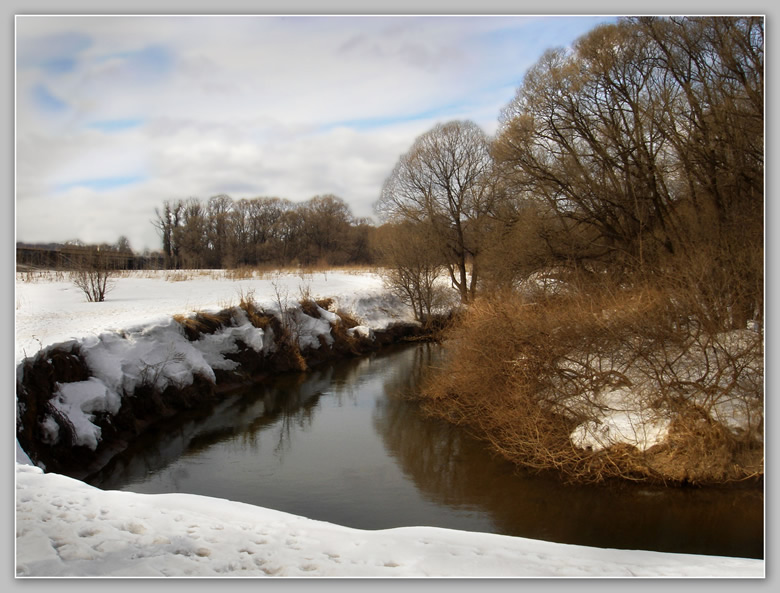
16, 271, 412, 450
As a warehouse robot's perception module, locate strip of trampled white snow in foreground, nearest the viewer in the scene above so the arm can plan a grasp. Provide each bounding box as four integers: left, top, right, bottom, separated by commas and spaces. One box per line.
16, 465, 764, 577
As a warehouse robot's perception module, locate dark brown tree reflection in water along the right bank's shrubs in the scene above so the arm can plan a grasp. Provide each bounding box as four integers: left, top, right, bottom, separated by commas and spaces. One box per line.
373, 345, 763, 556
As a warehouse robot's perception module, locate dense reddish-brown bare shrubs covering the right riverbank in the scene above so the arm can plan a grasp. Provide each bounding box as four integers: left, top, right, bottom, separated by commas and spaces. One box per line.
423, 288, 763, 483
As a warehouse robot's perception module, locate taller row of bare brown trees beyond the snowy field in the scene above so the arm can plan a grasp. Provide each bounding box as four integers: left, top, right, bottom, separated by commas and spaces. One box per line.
154, 195, 374, 269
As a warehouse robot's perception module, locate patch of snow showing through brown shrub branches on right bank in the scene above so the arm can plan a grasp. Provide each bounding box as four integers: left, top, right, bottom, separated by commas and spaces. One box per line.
560, 324, 764, 451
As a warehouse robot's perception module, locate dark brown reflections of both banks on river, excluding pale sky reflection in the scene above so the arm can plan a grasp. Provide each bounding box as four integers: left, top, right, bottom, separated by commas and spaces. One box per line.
90, 344, 763, 553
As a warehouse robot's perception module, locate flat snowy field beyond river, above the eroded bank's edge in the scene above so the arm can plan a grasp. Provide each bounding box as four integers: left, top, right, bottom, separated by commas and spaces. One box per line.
16, 270, 413, 364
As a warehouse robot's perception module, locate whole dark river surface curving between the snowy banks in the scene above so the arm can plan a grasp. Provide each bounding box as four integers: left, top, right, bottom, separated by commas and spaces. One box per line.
89, 345, 764, 558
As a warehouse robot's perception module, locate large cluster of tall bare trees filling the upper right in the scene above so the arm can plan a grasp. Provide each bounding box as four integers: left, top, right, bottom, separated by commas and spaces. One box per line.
493, 17, 764, 327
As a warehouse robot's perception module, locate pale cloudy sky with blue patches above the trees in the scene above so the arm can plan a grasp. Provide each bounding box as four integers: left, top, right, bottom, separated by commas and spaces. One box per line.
16, 16, 610, 251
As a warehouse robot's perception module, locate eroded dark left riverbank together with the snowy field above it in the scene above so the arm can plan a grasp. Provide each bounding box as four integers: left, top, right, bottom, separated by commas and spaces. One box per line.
17, 271, 432, 478
